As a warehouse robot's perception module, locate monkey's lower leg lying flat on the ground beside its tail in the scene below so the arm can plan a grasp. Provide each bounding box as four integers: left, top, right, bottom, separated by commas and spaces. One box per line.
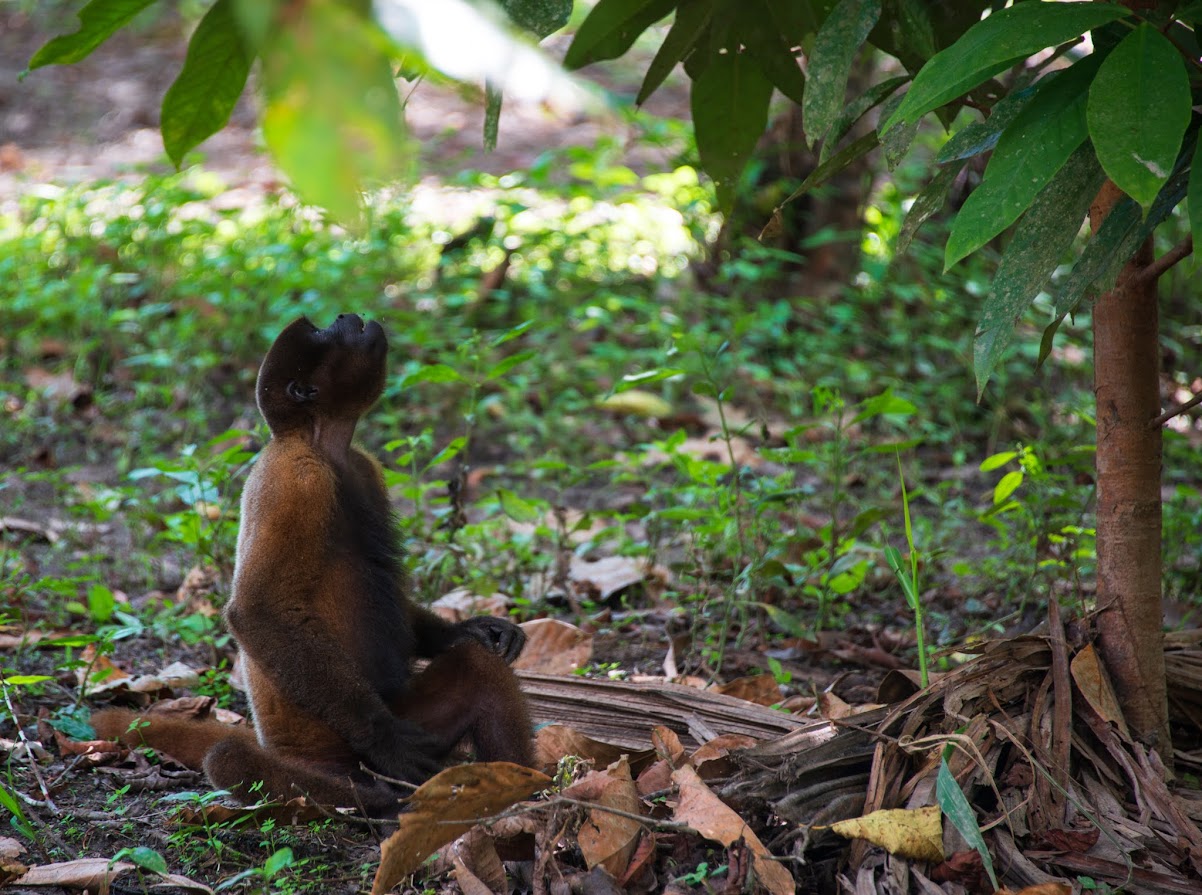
204, 738, 403, 817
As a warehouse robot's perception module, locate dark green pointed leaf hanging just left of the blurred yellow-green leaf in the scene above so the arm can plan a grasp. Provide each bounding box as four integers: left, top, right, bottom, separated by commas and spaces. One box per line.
161, 0, 252, 168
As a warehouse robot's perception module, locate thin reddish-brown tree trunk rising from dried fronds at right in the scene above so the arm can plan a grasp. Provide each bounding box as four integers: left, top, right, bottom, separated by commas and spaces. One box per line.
1089, 183, 1172, 763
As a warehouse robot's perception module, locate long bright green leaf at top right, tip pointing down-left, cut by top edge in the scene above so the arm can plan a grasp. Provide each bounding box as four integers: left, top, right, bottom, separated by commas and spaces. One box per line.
881, 2, 1127, 133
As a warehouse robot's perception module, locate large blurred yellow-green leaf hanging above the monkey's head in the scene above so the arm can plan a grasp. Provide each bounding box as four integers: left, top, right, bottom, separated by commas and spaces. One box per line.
263, 0, 411, 222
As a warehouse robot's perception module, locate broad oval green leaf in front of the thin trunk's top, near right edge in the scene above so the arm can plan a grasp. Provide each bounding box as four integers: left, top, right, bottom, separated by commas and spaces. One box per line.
1088, 23, 1191, 208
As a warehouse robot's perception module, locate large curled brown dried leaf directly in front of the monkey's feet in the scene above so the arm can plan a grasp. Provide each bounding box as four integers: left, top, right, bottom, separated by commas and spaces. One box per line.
371, 762, 551, 895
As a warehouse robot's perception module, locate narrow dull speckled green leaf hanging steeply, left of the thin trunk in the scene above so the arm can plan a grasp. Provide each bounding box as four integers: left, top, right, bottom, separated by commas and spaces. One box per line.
972, 143, 1106, 394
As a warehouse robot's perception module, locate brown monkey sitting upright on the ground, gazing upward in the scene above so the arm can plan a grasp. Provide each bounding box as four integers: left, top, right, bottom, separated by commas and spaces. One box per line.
100, 314, 532, 813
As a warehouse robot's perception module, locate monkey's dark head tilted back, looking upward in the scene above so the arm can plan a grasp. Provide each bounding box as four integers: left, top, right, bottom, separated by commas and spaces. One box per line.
255, 314, 388, 435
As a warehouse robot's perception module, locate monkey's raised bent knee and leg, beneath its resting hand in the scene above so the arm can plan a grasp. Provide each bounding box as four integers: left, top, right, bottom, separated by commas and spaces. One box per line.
393, 642, 534, 766
